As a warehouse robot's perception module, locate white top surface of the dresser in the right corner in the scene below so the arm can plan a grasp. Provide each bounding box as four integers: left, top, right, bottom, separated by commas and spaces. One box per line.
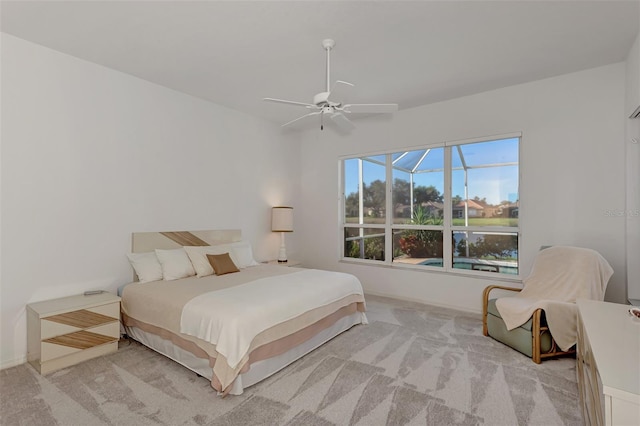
577, 300, 640, 402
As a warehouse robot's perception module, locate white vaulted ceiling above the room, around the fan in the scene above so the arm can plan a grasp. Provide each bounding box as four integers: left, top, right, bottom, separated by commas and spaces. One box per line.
0, 0, 640, 129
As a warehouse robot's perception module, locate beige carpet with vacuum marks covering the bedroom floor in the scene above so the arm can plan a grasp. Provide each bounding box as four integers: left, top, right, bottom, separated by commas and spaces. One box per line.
0, 296, 582, 426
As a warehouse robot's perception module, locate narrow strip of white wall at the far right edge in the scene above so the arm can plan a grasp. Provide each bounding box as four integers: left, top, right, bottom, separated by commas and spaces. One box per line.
625, 34, 640, 299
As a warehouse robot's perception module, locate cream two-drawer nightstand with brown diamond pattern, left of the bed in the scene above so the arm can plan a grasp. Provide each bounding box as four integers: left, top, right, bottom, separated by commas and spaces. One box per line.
27, 292, 120, 374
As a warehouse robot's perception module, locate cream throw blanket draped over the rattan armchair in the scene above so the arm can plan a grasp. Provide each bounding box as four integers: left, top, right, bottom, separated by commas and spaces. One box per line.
496, 246, 613, 351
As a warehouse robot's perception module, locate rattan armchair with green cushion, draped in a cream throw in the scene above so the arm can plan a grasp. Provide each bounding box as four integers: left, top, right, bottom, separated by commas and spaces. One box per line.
482, 246, 613, 364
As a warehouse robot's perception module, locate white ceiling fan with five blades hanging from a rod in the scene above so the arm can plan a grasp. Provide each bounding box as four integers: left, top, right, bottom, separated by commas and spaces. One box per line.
264, 38, 398, 131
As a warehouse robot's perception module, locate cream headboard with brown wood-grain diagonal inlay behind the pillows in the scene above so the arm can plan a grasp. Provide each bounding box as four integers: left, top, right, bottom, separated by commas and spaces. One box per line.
131, 229, 242, 253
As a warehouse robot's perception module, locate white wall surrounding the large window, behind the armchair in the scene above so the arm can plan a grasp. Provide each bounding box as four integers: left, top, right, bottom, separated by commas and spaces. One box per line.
295, 63, 626, 311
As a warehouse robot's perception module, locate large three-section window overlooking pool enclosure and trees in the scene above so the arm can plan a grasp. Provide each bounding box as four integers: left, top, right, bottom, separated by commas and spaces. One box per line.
341, 135, 520, 275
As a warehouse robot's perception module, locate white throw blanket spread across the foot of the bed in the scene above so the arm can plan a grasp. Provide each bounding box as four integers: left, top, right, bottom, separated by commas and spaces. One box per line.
180, 269, 366, 368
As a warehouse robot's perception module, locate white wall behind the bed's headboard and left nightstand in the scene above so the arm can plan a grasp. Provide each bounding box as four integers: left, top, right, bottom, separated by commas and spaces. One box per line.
0, 34, 299, 367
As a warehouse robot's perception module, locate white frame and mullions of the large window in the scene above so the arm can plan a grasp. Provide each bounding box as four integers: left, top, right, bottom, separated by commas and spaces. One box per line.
338, 132, 523, 281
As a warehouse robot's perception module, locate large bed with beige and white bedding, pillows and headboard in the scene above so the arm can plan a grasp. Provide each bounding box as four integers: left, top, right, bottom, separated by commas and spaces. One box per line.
119, 230, 367, 395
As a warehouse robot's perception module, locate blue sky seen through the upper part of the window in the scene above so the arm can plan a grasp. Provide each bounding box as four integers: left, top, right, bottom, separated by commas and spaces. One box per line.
345, 138, 519, 205
